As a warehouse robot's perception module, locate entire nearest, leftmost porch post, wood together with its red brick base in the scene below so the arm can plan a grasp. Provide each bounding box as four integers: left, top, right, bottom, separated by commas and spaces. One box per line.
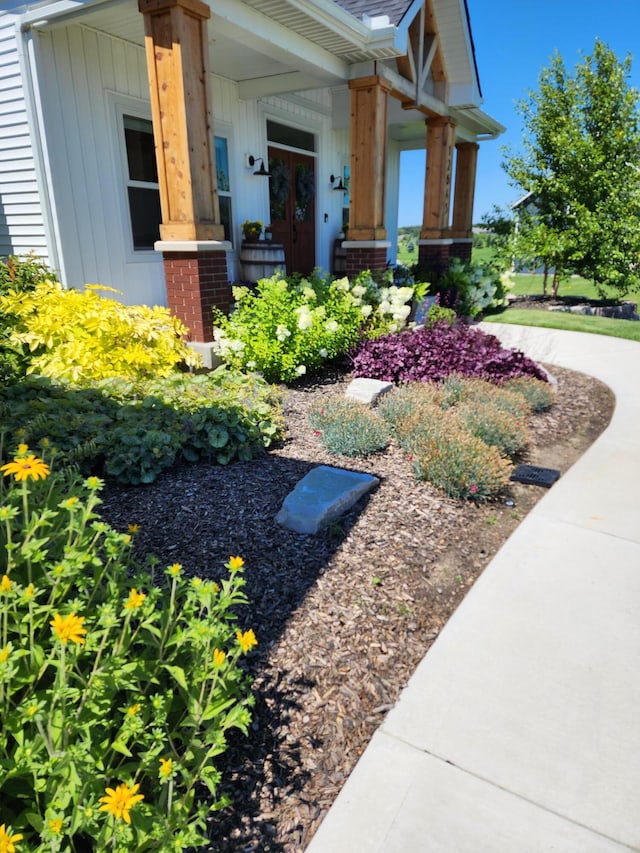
138, 0, 231, 350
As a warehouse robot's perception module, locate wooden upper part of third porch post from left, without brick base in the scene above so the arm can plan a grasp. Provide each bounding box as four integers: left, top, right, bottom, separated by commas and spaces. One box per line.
420, 117, 456, 239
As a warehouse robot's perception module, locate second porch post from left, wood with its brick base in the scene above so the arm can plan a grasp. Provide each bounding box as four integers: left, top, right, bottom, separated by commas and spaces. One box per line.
344, 75, 391, 275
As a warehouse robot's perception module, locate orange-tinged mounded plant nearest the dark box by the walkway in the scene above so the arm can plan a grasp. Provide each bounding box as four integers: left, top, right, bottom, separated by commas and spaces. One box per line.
408, 420, 513, 501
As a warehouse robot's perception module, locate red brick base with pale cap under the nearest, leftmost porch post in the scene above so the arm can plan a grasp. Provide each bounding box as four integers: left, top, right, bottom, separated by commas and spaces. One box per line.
156, 242, 232, 343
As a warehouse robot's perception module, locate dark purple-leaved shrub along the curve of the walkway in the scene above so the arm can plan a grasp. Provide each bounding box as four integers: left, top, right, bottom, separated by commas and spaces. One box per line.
352, 324, 546, 383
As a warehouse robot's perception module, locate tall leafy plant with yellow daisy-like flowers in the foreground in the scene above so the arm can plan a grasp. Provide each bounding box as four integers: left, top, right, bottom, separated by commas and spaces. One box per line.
0, 445, 257, 853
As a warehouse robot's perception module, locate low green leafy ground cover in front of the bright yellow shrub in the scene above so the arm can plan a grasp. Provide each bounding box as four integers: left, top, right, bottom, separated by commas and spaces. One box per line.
0, 368, 283, 483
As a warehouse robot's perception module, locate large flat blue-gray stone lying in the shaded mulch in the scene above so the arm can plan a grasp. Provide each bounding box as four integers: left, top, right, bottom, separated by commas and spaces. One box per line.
276, 465, 380, 533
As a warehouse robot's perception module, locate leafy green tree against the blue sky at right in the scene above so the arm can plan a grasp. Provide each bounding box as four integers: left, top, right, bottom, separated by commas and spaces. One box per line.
503, 40, 640, 294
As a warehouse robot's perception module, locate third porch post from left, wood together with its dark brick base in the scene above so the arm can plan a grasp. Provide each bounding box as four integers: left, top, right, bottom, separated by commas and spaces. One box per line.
418, 116, 456, 272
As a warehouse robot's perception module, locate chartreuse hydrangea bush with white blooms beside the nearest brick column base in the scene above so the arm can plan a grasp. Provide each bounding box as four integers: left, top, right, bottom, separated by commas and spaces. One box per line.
213, 272, 413, 382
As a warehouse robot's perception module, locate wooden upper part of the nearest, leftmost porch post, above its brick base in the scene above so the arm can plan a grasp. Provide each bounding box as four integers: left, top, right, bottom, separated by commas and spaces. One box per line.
138, 0, 224, 241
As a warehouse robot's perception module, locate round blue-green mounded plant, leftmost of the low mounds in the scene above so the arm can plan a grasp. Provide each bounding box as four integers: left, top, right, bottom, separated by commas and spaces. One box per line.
309, 397, 389, 456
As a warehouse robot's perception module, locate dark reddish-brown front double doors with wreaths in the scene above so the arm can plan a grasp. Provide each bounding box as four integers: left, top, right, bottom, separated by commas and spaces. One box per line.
269, 145, 316, 275
